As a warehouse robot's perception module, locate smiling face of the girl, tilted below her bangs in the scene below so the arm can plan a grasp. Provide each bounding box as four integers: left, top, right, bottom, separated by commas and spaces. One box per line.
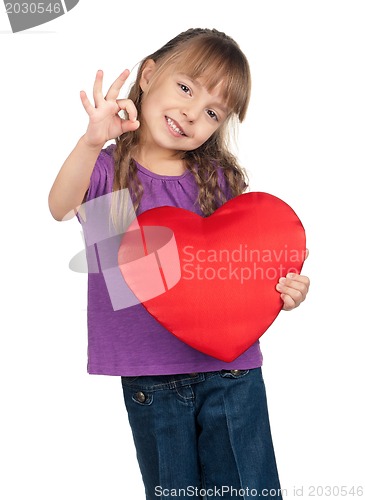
141, 61, 228, 153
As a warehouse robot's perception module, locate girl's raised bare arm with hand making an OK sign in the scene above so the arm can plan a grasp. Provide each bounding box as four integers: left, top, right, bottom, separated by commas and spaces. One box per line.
48, 70, 139, 221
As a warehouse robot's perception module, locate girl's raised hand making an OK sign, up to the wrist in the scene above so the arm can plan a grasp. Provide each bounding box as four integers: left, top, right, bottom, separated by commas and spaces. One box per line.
80, 69, 139, 147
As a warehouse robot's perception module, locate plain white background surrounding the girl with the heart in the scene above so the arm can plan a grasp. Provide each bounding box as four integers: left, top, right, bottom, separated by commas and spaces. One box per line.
0, 0, 365, 500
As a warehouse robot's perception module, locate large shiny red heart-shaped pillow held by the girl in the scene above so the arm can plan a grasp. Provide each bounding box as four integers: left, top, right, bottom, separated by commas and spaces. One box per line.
118, 192, 305, 362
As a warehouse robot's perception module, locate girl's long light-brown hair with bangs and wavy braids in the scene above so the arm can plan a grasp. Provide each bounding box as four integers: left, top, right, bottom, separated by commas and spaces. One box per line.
113, 28, 251, 225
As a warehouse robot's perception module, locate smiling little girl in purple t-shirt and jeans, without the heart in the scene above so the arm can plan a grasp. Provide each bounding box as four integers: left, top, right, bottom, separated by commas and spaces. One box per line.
49, 29, 309, 500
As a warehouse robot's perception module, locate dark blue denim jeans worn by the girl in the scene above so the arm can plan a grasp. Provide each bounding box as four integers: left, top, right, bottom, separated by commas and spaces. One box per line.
122, 368, 282, 500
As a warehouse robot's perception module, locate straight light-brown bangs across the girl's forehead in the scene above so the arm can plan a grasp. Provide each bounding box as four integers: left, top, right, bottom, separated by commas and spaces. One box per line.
154, 36, 251, 121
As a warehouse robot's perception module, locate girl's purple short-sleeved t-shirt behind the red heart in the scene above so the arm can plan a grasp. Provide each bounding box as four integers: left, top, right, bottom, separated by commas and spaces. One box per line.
78, 144, 262, 376
